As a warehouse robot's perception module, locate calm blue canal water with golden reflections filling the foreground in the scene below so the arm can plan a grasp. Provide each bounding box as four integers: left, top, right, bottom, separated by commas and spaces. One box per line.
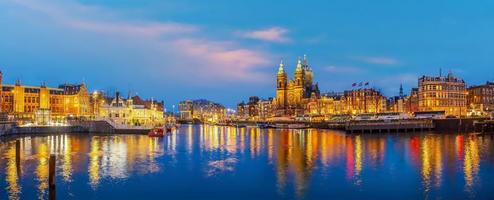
0, 125, 494, 199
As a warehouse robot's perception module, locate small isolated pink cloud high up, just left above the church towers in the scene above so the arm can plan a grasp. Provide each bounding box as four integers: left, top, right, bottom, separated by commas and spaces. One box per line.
238, 27, 291, 43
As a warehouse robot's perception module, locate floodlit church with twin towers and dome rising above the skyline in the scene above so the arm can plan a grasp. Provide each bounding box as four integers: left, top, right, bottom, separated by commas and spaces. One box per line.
273, 55, 320, 116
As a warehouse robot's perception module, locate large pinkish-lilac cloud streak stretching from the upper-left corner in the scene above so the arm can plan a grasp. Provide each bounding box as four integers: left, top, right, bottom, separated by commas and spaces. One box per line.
0, 0, 270, 84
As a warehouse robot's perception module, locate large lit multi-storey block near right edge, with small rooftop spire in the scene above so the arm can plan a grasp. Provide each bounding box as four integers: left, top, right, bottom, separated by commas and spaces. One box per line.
418, 72, 467, 116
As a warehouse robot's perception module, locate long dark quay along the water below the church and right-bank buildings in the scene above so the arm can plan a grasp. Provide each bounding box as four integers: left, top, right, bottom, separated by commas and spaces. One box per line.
179, 118, 494, 134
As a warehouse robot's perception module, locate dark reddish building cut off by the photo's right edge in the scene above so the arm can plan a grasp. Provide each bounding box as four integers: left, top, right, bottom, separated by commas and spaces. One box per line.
467, 82, 494, 115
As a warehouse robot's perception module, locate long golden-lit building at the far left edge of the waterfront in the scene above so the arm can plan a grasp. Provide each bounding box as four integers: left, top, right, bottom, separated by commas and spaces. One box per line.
0, 72, 92, 125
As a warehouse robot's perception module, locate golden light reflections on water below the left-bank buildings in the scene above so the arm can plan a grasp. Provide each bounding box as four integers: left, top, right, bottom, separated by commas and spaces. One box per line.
0, 135, 163, 195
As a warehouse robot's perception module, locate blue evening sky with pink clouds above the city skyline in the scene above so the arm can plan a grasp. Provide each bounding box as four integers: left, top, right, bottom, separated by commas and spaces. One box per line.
0, 0, 494, 108
